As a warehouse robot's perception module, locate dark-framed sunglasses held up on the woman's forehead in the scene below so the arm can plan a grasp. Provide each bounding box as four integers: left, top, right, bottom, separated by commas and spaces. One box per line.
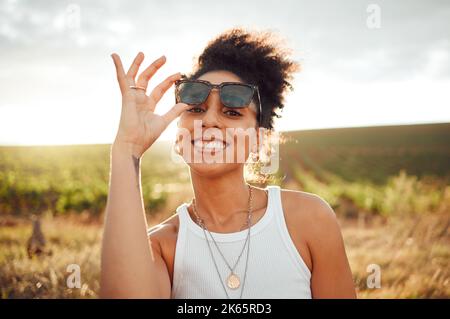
175, 79, 262, 123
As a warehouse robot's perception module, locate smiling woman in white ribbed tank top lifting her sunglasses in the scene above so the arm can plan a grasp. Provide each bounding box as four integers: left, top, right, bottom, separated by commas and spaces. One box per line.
100, 28, 355, 298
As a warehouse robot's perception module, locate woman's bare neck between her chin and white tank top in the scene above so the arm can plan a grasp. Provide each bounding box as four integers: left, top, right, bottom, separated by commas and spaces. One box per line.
191, 171, 255, 231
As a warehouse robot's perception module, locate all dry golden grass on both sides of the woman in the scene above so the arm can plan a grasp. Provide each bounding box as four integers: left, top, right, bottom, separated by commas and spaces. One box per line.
0, 213, 450, 298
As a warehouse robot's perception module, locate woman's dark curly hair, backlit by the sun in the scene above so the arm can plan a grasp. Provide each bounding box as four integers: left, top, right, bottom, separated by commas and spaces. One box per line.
185, 27, 300, 129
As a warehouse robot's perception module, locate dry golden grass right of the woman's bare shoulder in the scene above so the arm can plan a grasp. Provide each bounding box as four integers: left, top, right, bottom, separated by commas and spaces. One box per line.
342, 214, 450, 298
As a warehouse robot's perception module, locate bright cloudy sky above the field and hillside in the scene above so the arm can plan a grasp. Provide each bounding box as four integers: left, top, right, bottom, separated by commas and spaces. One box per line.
0, 0, 450, 144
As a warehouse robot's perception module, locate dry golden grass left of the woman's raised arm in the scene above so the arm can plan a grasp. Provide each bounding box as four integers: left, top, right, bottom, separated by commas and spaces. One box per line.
0, 217, 101, 298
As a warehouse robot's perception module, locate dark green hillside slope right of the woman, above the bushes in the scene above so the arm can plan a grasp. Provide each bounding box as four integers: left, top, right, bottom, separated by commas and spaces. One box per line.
282, 123, 450, 185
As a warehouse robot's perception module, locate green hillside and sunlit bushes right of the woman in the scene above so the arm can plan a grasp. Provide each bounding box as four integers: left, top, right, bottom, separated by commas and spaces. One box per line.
281, 124, 450, 216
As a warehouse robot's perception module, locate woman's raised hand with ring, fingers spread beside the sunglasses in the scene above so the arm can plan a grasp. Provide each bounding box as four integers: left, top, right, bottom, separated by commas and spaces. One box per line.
111, 52, 188, 158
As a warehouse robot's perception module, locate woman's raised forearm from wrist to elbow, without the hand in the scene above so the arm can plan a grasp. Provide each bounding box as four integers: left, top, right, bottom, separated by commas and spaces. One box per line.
100, 143, 171, 298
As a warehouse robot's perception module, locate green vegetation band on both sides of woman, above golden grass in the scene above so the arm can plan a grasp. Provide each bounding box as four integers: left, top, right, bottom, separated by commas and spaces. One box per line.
0, 124, 450, 220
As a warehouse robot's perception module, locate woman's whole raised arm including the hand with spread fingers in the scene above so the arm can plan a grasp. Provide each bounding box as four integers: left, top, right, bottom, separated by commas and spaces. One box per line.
100, 52, 188, 298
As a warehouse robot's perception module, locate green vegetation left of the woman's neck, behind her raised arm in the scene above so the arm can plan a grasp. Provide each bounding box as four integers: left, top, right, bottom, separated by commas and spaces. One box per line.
0, 144, 188, 215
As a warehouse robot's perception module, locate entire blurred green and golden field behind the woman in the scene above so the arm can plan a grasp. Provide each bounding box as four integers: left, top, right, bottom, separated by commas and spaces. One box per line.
0, 123, 450, 298
